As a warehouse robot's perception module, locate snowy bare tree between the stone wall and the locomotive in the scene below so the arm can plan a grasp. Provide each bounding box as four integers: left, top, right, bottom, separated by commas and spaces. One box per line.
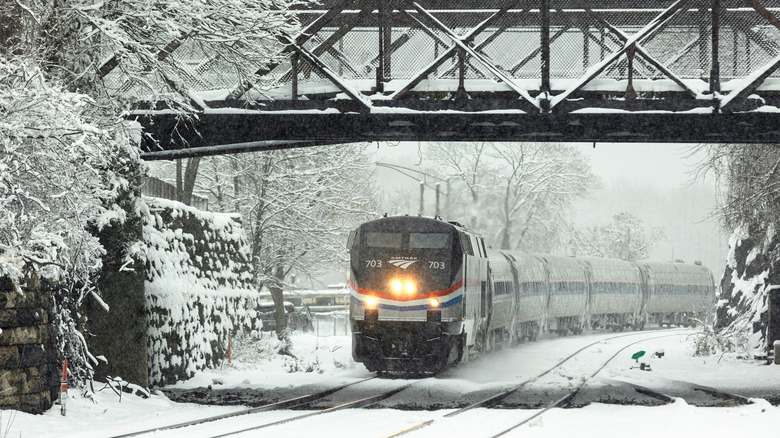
245, 144, 374, 336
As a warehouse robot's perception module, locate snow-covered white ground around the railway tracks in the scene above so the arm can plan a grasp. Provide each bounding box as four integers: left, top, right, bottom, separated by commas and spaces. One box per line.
6, 330, 780, 438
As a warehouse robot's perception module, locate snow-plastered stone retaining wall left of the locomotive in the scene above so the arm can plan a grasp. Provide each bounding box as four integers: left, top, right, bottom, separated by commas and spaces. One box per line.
143, 198, 262, 385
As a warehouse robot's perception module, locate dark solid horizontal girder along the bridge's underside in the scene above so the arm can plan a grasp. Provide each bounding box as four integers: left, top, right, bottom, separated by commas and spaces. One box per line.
134, 112, 780, 159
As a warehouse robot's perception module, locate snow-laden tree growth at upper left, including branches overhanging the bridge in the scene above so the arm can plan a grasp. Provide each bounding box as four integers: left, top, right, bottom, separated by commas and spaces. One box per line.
0, 0, 308, 379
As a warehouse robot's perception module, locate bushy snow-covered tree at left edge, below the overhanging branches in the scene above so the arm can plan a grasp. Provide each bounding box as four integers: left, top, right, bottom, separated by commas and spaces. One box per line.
0, 57, 145, 381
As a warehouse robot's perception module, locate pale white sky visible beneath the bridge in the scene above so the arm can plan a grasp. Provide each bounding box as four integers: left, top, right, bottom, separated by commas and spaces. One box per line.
369, 142, 728, 281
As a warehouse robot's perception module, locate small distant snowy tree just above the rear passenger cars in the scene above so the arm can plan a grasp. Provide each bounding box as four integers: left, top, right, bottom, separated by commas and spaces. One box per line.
571, 211, 664, 260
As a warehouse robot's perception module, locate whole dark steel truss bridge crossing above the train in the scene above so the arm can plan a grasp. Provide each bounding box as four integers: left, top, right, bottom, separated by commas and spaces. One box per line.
122, 0, 780, 159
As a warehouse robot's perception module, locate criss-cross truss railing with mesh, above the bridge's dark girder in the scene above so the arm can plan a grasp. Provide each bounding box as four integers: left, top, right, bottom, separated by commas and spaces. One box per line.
109, 0, 780, 103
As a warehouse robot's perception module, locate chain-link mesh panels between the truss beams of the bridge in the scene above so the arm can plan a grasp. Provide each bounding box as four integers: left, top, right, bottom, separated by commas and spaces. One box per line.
104, 0, 780, 98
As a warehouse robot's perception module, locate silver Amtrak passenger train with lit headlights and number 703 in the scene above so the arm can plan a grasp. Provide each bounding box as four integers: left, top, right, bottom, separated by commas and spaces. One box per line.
347, 215, 715, 375
